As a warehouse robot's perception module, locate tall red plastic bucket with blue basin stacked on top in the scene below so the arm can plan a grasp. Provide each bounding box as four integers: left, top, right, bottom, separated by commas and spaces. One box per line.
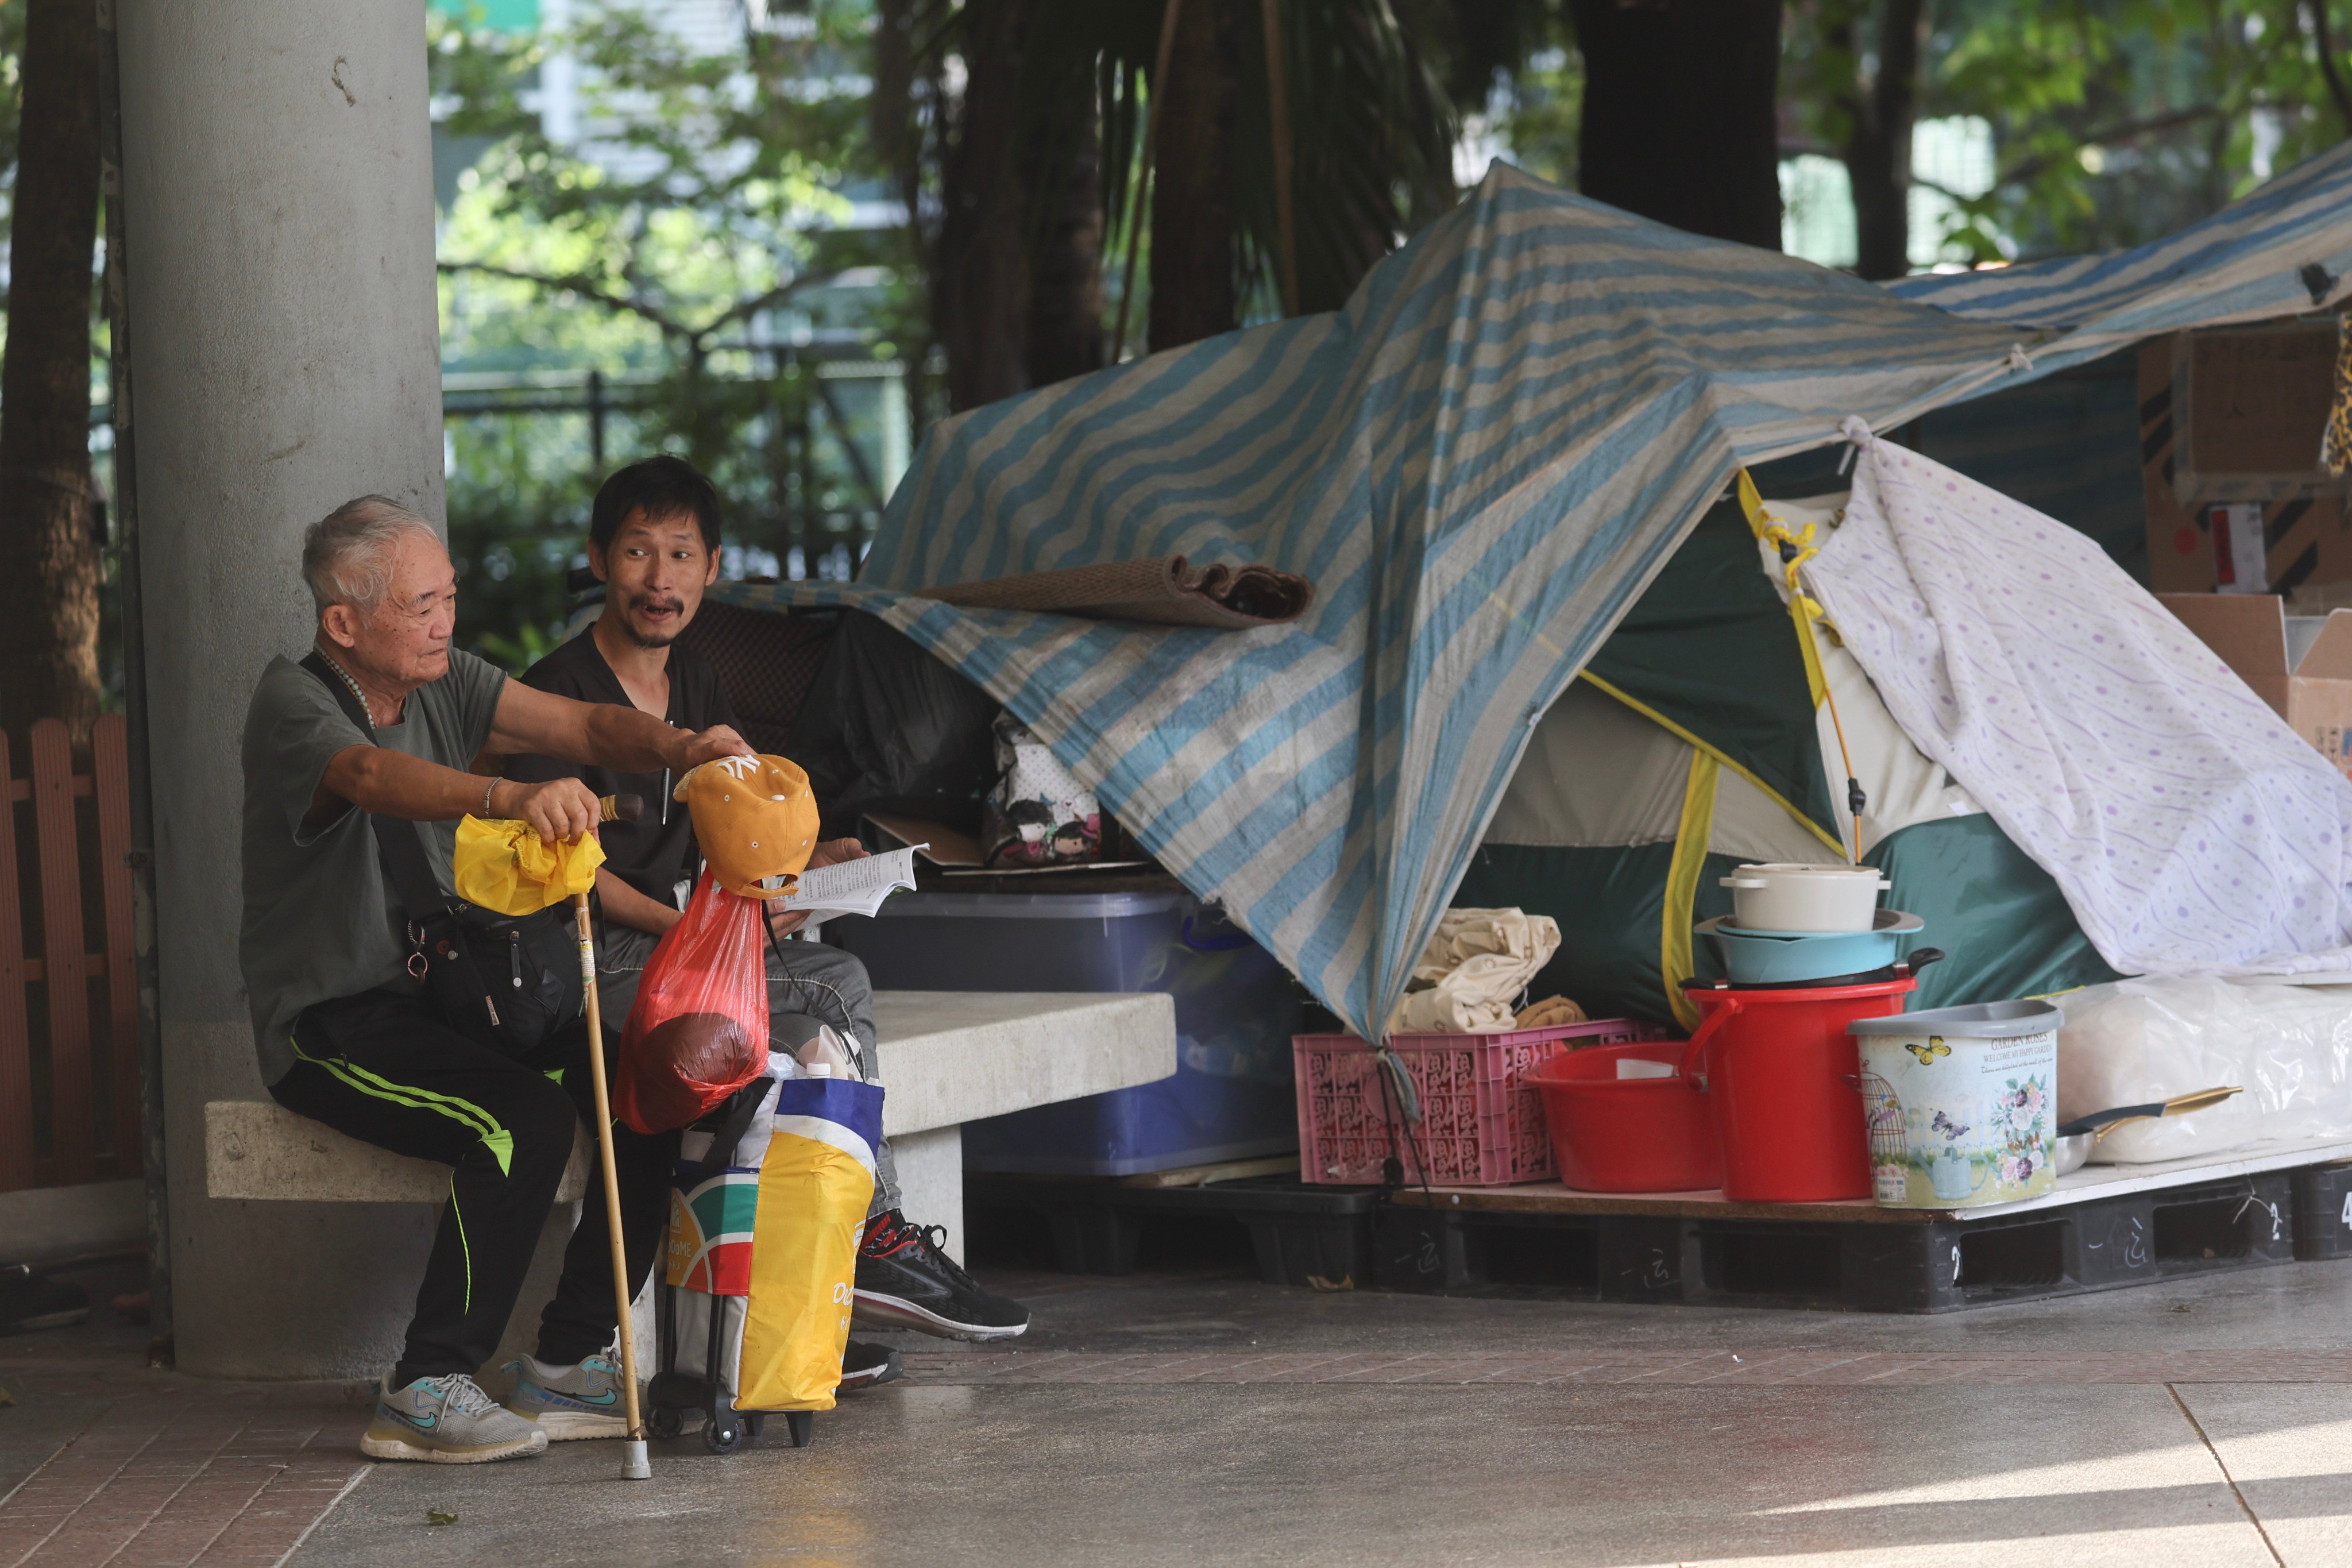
1682, 978, 1920, 1204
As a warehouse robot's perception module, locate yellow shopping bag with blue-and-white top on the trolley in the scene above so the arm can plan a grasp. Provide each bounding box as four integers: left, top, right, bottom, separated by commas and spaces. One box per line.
736, 1079, 882, 1411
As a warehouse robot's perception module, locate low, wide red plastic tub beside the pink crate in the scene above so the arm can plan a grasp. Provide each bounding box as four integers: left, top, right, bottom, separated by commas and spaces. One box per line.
1519, 1039, 1724, 1192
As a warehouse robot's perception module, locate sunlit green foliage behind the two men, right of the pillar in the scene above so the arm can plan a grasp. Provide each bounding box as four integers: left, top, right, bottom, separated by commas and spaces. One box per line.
430, 2, 896, 667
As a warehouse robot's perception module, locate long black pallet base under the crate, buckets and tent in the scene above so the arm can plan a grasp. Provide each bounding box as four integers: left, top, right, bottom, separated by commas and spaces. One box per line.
964, 1142, 2352, 1312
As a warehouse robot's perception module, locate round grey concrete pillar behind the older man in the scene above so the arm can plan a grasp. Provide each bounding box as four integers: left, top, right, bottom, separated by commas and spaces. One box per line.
118, 0, 442, 1377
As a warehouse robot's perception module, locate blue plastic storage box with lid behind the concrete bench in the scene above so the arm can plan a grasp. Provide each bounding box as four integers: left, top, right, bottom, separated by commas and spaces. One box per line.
828, 893, 1303, 1175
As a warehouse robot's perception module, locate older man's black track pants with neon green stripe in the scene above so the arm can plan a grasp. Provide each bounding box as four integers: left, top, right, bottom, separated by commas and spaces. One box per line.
271, 992, 677, 1387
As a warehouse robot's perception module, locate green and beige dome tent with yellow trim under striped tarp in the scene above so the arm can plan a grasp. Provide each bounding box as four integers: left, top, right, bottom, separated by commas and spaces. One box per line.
1454, 475, 2114, 1028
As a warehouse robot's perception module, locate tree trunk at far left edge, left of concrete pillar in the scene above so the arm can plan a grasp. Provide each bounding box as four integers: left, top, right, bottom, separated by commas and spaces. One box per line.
0, 0, 99, 745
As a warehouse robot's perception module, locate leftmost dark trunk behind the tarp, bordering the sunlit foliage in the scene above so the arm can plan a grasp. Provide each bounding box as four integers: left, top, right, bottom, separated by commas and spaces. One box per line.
932, 0, 1030, 411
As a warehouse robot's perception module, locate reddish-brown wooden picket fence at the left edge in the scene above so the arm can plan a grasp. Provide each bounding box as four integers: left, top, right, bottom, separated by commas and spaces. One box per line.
0, 712, 141, 1192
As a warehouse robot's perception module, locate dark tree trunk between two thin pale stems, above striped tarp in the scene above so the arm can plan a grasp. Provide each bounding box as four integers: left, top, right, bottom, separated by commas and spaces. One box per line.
1150, 0, 1256, 350
